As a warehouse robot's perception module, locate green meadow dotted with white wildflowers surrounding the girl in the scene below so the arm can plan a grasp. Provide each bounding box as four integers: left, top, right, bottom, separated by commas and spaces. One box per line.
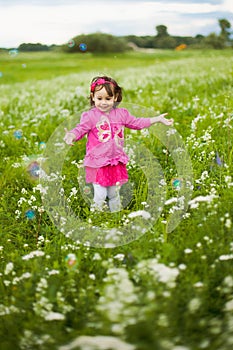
0, 50, 233, 350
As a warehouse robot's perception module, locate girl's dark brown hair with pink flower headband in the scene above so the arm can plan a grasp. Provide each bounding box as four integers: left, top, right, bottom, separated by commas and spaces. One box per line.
89, 75, 122, 107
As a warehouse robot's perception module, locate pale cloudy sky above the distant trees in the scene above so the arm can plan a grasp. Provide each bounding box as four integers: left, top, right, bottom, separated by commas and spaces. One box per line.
0, 0, 233, 48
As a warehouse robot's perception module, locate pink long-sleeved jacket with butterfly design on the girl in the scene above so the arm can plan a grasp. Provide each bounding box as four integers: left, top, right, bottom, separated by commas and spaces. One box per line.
70, 108, 151, 168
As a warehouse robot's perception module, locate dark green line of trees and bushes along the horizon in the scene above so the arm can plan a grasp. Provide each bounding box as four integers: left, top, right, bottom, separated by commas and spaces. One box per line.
9, 18, 233, 53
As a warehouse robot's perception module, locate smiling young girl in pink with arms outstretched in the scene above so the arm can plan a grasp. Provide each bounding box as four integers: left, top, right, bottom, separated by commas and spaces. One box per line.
64, 76, 173, 212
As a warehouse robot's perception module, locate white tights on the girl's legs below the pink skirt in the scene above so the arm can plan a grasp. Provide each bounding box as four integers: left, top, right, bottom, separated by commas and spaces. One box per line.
93, 184, 121, 212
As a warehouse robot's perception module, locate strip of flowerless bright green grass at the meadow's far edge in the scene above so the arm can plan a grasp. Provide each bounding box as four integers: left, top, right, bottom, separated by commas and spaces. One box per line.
0, 50, 231, 84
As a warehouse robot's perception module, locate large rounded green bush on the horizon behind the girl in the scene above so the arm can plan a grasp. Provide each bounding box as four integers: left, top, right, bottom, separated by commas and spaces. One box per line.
61, 33, 129, 53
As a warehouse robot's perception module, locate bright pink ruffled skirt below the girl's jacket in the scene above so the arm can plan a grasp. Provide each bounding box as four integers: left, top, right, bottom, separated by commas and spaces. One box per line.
85, 163, 128, 187
